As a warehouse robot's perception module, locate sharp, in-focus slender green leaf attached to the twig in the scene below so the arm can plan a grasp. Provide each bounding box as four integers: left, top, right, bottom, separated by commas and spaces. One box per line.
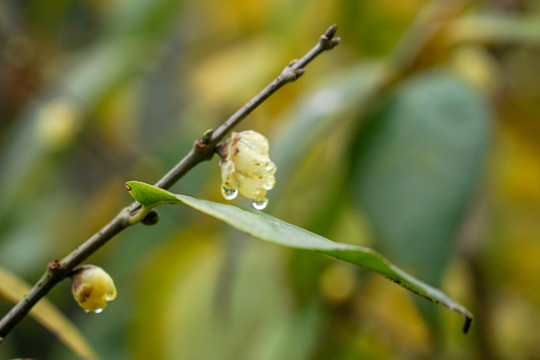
127, 181, 472, 332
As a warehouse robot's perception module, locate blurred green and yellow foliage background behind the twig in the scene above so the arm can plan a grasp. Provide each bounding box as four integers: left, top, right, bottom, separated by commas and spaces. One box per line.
0, 0, 540, 359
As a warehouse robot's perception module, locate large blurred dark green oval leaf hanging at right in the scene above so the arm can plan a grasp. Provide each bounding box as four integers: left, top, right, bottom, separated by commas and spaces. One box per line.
351, 72, 490, 284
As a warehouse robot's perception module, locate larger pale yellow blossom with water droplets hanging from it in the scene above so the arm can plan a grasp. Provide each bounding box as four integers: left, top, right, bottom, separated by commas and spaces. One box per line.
218, 130, 276, 210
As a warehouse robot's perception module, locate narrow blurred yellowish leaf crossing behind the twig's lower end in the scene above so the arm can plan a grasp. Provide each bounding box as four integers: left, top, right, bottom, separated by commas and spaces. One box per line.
0, 268, 99, 359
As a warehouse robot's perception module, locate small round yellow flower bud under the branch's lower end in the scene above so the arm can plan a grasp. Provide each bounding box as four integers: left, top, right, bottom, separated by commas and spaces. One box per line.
71, 265, 116, 314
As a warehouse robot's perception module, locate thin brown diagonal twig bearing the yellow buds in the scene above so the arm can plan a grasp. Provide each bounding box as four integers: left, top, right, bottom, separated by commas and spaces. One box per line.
0, 25, 340, 343
